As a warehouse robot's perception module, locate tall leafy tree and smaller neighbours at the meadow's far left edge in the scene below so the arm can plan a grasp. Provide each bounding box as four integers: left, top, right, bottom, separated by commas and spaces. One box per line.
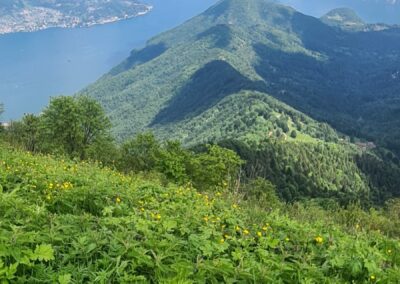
7, 97, 115, 161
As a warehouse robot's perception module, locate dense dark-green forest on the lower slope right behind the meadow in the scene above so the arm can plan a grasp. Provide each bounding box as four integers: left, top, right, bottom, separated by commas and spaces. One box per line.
219, 140, 400, 207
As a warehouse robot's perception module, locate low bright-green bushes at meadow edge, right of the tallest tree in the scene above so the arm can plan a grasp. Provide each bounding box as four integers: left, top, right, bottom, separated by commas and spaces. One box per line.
118, 133, 242, 189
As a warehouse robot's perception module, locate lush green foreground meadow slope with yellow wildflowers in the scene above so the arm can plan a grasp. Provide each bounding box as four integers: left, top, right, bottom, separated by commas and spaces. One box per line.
0, 144, 400, 284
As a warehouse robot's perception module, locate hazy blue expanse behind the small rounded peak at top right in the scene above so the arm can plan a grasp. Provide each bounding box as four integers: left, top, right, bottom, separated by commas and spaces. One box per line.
277, 0, 400, 24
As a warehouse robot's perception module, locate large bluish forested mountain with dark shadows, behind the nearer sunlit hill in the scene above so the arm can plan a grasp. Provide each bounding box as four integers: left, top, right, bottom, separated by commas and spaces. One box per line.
82, 0, 400, 153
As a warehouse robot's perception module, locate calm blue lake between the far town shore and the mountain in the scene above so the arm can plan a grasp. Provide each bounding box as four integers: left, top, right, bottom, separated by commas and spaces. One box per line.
0, 0, 217, 121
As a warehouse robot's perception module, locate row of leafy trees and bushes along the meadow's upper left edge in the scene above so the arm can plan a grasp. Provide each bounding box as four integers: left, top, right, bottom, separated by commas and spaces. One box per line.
3, 96, 243, 190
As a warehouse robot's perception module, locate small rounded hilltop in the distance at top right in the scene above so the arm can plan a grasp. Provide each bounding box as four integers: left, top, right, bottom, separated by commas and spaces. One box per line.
321, 8, 365, 30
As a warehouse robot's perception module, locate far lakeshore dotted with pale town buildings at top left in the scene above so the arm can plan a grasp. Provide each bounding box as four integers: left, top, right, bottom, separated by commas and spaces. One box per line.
0, 0, 151, 34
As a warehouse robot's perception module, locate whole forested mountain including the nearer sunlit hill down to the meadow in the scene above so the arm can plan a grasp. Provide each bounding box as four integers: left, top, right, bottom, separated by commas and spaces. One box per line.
81, 0, 400, 202
